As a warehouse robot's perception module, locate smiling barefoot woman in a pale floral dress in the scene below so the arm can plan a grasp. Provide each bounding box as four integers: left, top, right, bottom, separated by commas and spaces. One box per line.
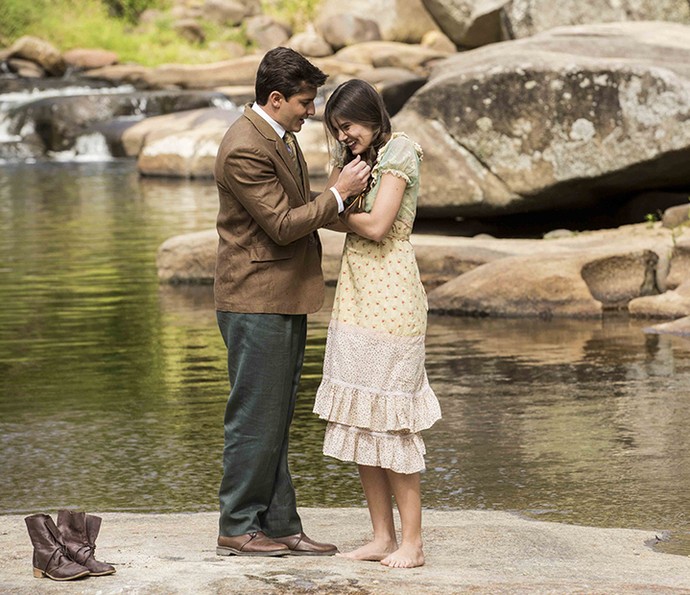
314, 80, 441, 568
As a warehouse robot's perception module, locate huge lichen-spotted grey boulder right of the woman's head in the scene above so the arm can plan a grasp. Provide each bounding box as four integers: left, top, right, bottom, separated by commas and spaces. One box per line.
392, 23, 690, 217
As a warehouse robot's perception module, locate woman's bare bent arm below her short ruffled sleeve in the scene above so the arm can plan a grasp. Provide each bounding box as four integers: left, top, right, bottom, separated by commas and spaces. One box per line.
340, 173, 407, 242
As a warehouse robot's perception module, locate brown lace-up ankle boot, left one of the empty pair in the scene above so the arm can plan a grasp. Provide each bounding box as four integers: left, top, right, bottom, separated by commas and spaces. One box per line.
24, 514, 89, 581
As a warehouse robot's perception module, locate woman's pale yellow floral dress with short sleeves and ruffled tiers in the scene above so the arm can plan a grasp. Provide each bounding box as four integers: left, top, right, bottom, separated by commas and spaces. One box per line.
314, 133, 441, 473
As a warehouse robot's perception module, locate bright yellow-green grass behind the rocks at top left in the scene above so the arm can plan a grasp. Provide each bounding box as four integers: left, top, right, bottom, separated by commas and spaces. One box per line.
0, 0, 320, 66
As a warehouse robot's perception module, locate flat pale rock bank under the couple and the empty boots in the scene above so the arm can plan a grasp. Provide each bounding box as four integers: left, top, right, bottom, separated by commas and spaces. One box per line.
0, 508, 690, 595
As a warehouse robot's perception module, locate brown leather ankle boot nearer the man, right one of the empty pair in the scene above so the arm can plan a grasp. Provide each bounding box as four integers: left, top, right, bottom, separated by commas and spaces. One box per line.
58, 510, 115, 576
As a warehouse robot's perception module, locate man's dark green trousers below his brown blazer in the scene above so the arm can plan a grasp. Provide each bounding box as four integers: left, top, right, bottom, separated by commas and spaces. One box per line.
216, 312, 307, 537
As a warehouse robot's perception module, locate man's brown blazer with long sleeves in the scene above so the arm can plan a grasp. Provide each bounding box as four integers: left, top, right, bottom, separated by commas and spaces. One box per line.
214, 106, 338, 314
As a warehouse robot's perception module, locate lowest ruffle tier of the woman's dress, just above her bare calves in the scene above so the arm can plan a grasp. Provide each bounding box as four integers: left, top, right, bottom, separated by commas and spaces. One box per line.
323, 423, 426, 474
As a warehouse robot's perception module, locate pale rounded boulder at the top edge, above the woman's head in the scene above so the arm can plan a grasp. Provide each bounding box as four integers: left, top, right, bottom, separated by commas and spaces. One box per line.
317, 0, 439, 43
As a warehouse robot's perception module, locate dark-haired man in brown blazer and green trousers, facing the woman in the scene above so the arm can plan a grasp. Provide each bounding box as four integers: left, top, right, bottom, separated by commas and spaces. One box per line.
214, 48, 370, 556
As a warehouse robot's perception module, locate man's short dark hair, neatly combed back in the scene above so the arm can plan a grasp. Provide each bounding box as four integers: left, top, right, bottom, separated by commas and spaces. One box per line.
254, 47, 328, 105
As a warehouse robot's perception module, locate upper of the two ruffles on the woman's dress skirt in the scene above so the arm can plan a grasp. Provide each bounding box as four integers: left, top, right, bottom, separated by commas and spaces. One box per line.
314, 374, 441, 433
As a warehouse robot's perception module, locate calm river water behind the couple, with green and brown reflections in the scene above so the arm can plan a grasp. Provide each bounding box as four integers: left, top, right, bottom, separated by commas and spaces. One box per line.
0, 161, 690, 555
